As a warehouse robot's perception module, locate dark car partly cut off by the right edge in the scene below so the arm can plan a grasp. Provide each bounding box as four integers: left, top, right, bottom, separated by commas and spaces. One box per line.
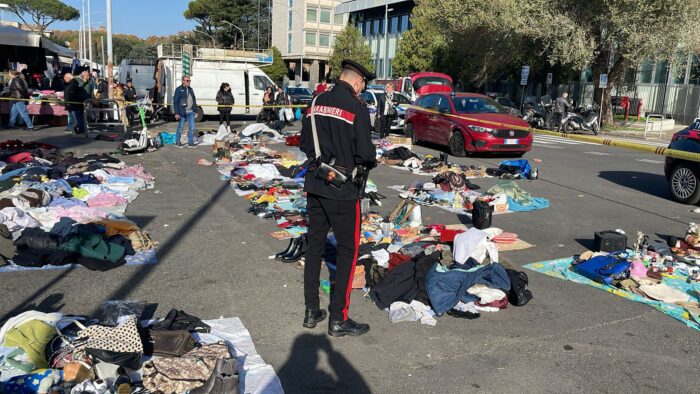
664, 119, 700, 205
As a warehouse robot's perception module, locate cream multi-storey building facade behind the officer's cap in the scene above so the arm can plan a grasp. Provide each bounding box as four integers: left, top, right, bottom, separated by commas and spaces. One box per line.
272, 0, 347, 88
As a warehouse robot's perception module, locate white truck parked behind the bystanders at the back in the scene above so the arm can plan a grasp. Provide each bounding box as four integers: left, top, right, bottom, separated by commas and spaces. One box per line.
156, 44, 275, 122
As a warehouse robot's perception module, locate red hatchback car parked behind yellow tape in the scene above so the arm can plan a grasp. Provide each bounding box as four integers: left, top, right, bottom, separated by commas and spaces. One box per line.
404, 93, 532, 156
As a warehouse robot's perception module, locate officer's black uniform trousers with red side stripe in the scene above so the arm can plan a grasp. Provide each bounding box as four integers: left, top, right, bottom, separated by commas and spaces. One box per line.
304, 192, 361, 321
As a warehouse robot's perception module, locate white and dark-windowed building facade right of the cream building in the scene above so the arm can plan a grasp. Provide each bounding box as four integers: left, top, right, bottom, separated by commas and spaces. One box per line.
335, 0, 415, 79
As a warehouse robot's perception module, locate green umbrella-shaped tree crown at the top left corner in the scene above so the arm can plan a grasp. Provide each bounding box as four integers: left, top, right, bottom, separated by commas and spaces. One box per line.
4, 0, 80, 33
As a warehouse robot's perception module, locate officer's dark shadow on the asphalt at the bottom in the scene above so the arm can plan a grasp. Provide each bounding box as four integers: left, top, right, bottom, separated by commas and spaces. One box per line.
278, 332, 371, 393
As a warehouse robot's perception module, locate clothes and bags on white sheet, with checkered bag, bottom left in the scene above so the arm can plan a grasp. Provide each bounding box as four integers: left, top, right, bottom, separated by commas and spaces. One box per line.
0, 301, 282, 394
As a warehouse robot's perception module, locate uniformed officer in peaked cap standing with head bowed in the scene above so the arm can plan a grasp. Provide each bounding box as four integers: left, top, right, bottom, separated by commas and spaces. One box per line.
300, 60, 376, 336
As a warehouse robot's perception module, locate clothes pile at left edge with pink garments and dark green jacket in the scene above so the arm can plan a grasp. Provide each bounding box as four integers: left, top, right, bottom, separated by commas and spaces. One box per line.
0, 141, 156, 271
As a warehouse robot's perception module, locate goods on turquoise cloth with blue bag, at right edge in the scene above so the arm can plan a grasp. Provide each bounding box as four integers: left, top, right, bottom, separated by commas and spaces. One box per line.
525, 223, 700, 330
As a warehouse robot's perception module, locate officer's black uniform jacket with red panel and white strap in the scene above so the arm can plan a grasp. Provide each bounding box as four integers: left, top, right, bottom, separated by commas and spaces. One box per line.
299, 81, 376, 200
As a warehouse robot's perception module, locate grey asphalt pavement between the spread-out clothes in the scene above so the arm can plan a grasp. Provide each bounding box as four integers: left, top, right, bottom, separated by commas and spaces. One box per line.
0, 123, 700, 393
